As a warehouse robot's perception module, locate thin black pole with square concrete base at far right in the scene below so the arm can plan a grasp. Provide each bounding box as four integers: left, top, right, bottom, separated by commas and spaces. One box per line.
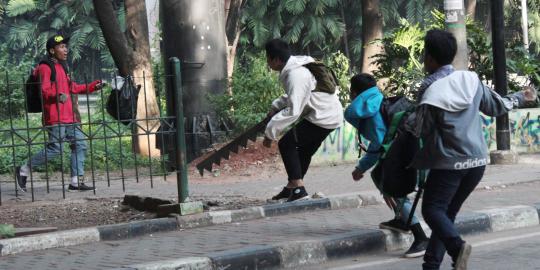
490, 0, 518, 164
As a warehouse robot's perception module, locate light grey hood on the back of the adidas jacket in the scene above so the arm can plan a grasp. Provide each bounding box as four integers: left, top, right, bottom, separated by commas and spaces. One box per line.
420, 71, 480, 112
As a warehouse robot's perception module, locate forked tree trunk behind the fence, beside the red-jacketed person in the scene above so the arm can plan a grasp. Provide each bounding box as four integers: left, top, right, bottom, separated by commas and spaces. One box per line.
94, 0, 160, 156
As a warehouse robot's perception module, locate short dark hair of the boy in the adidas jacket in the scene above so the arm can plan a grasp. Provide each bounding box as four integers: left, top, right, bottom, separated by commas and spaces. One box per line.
424, 29, 457, 66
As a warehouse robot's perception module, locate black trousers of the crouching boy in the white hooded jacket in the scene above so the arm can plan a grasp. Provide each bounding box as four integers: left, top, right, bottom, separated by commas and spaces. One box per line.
278, 119, 333, 181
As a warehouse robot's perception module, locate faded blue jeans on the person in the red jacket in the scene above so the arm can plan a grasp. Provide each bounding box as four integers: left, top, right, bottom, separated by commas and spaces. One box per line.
28, 123, 86, 177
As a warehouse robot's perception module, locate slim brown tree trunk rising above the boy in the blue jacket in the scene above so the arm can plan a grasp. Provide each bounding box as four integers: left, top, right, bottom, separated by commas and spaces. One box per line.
361, 0, 383, 73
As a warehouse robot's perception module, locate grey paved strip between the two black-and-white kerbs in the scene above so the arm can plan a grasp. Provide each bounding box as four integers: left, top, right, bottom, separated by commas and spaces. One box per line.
0, 178, 540, 270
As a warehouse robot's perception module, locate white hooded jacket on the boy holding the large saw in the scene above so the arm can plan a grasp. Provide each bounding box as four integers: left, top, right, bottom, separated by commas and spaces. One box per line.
265, 56, 343, 140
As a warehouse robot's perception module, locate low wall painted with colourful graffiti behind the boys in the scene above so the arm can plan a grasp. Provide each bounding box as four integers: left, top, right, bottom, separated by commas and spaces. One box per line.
313, 109, 540, 163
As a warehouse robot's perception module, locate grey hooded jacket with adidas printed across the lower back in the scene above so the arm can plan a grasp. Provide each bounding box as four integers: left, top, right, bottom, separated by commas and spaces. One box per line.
411, 69, 524, 170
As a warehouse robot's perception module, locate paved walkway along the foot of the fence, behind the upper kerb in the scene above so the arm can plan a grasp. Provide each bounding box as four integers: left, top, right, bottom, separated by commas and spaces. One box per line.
1, 154, 540, 205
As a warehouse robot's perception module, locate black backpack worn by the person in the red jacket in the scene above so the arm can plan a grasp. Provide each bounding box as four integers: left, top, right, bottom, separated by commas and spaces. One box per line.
24, 60, 56, 113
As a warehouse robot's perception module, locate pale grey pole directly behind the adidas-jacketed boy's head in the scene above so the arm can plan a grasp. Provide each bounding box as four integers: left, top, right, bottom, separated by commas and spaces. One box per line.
444, 0, 469, 70
